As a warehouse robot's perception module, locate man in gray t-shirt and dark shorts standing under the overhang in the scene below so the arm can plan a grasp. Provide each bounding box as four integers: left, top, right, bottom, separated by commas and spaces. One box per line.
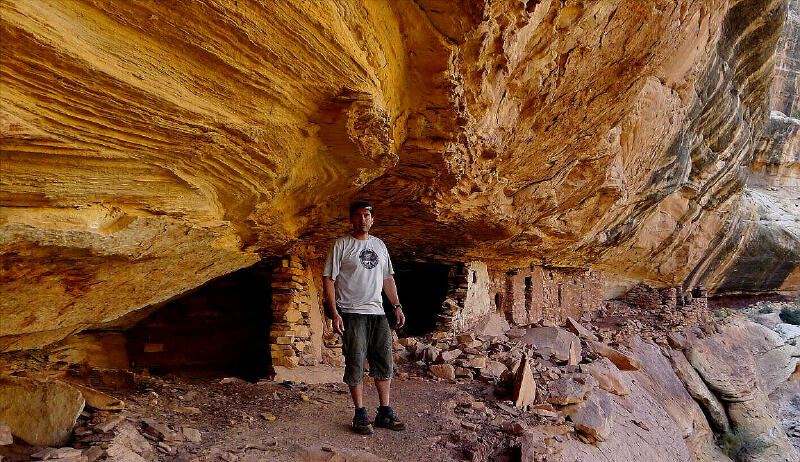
322, 202, 406, 435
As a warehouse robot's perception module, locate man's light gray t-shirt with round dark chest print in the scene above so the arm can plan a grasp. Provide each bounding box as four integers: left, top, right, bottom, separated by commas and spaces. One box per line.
322, 234, 394, 314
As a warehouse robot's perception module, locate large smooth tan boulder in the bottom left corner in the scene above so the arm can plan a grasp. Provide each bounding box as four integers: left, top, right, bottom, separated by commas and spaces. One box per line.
0, 375, 85, 446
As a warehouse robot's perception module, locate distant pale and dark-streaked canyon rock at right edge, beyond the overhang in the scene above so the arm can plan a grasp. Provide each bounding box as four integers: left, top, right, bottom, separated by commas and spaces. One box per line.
693, 111, 800, 291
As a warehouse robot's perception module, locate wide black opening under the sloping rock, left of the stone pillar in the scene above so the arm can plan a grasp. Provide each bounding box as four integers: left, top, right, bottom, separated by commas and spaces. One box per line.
126, 263, 271, 381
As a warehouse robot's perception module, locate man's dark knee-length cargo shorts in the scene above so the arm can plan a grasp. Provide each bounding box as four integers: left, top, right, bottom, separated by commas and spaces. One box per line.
342, 313, 393, 386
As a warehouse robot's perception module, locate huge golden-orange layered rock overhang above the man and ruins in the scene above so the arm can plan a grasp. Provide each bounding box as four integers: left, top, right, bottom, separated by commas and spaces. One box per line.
0, 0, 787, 350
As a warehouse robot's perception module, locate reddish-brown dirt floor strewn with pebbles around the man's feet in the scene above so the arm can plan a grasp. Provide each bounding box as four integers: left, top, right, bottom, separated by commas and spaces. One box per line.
123, 377, 510, 461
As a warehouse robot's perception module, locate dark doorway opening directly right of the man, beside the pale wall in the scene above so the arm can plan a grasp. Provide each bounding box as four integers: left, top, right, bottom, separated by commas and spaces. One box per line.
383, 261, 450, 337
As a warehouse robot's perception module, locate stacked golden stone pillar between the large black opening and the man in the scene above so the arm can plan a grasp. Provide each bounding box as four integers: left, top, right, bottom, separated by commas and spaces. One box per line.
269, 256, 311, 367
